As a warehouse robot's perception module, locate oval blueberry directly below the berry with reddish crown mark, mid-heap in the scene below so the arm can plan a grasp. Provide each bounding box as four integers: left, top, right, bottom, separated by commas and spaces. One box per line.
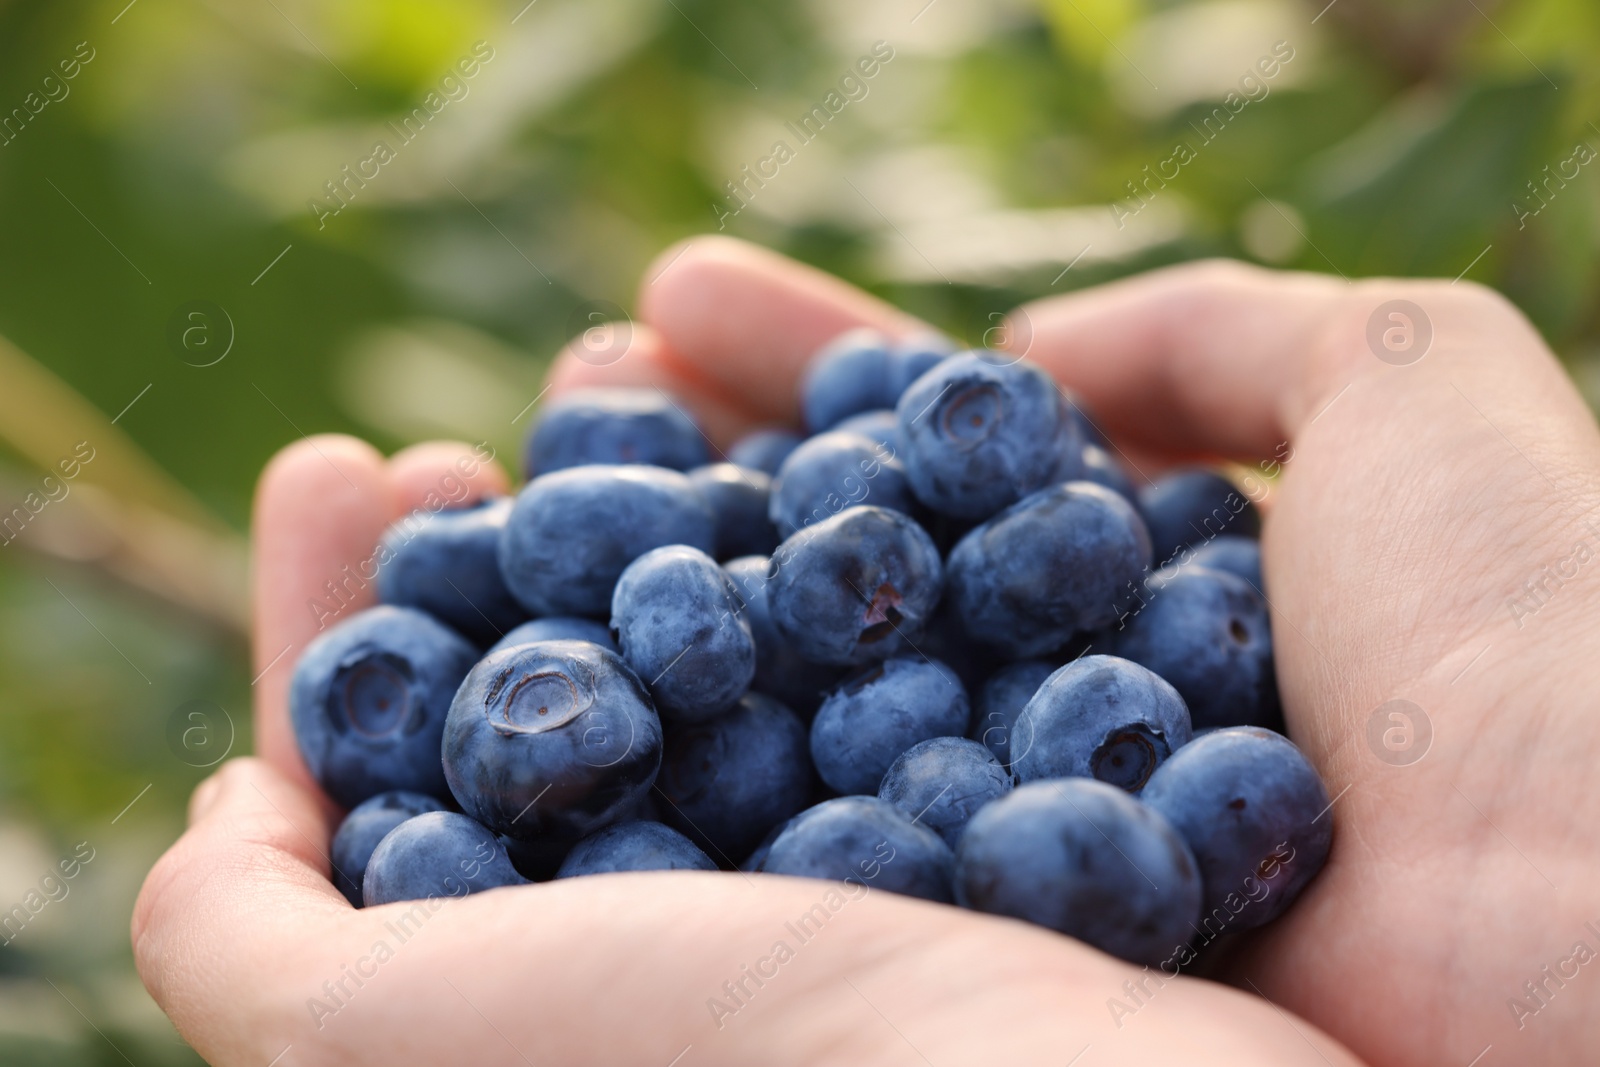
811, 656, 971, 793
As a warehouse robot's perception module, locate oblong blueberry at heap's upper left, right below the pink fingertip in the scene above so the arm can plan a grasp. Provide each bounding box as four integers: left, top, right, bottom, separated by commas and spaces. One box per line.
523, 389, 710, 478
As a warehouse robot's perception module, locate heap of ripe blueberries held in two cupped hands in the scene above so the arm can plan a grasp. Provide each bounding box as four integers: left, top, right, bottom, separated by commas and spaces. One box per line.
291, 330, 1333, 965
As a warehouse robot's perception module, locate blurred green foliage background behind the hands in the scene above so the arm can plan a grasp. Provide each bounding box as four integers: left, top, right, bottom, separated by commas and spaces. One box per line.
0, 0, 1600, 1067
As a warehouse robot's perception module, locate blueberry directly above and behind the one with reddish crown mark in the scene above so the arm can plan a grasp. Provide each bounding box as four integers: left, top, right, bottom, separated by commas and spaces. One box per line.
768, 430, 917, 537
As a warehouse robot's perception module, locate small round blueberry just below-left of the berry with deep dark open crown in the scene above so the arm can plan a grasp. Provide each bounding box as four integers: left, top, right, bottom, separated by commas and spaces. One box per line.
878, 737, 1011, 848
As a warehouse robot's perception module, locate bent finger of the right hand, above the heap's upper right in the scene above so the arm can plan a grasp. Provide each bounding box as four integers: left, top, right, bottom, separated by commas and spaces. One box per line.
1005, 261, 1350, 458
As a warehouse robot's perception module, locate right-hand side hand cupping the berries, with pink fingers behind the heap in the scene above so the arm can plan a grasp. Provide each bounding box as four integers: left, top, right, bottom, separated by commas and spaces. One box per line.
555, 242, 1600, 1067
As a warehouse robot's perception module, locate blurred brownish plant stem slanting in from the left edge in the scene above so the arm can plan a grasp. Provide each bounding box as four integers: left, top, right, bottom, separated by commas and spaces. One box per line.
0, 338, 250, 638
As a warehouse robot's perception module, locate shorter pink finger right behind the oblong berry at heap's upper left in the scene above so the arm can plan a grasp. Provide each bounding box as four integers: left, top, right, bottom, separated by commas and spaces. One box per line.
546, 323, 771, 447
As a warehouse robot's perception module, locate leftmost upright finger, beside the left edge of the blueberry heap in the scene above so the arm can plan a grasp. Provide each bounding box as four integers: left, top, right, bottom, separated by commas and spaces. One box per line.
251, 434, 394, 782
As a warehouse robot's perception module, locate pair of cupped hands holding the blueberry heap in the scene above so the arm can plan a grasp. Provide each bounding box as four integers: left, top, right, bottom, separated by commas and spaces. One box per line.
133, 237, 1600, 1067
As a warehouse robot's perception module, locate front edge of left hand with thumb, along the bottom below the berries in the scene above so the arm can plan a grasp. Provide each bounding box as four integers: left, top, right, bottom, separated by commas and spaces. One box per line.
133, 760, 1355, 1067
